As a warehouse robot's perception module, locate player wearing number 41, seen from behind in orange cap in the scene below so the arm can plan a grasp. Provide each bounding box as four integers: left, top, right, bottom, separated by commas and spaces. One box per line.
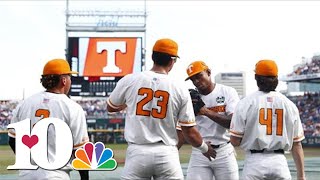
230, 60, 305, 180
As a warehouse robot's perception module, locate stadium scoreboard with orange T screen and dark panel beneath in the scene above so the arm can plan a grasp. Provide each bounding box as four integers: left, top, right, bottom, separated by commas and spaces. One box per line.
67, 37, 143, 97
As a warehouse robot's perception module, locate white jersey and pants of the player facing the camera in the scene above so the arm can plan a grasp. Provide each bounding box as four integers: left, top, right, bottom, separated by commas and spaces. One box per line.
187, 84, 239, 180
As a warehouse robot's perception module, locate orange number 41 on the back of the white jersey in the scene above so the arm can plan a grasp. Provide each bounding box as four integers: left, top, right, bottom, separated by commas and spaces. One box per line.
259, 108, 283, 136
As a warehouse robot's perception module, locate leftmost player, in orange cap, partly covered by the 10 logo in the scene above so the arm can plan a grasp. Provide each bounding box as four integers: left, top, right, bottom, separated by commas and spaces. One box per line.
8, 59, 89, 180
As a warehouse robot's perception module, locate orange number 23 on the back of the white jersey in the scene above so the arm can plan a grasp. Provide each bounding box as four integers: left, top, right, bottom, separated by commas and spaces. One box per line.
136, 88, 169, 119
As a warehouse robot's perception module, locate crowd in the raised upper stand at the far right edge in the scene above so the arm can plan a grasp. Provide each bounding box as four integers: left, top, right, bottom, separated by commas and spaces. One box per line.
288, 55, 320, 76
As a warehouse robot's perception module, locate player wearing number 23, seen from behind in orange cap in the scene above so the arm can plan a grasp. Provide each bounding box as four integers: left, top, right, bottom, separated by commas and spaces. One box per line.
107, 39, 215, 180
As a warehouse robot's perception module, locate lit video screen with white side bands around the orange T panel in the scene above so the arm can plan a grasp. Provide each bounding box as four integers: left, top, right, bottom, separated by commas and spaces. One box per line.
68, 37, 142, 77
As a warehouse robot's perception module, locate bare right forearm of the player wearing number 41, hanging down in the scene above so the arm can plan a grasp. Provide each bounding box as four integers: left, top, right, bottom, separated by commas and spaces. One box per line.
292, 142, 305, 180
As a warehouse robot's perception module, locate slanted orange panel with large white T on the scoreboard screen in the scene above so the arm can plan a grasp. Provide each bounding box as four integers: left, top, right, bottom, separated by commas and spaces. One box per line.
83, 38, 139, 77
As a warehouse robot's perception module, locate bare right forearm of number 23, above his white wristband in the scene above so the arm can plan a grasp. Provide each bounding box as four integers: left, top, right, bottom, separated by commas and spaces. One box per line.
181, 126, 202, 147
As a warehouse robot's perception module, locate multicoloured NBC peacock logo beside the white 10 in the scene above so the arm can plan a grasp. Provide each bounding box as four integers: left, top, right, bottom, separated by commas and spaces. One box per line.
72, 142, 117, 171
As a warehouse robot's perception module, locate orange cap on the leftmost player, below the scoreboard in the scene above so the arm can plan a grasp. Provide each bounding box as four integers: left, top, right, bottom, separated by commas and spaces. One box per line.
42, 59, 78, 75
